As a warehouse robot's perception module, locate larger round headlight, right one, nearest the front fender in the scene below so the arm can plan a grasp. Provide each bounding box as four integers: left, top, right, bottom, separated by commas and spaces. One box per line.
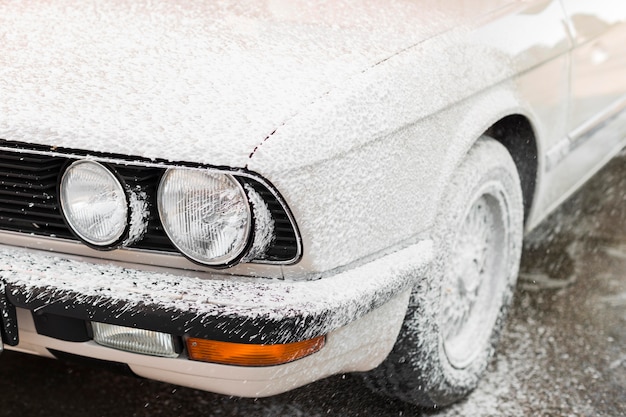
157, 169, 252, 265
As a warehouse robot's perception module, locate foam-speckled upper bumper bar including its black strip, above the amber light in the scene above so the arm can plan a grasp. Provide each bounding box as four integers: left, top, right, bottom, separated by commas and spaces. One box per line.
0, 241, 432, 344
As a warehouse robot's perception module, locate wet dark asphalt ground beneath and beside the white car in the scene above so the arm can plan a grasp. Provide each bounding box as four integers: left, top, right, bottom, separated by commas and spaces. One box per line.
0, 152, 626, 417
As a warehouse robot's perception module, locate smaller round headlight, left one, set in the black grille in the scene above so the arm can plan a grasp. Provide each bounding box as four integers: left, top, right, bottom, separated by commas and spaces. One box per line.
59, 160, 128, 247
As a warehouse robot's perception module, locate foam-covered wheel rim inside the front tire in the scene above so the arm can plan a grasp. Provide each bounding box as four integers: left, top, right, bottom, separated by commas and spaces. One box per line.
441, 193, 508, 369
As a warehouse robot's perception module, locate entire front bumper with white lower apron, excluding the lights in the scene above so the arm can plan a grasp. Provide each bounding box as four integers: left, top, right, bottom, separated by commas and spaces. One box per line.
0, 241, 432, 396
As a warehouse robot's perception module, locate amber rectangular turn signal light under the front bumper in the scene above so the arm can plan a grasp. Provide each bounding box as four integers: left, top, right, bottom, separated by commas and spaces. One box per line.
187, 336, 326, 366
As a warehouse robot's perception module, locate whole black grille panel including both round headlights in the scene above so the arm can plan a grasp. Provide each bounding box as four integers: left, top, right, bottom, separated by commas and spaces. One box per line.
15, 144, 302, 270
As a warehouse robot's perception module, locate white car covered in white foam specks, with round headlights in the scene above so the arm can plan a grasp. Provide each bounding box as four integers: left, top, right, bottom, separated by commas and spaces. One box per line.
0, 0, 626, 406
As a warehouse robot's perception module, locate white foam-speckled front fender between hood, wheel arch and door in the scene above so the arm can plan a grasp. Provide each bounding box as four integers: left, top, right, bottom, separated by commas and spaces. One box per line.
248, 2, 571, 276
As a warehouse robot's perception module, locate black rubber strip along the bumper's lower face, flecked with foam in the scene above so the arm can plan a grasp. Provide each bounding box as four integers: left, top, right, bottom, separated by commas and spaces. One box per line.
7, 284, 328, 344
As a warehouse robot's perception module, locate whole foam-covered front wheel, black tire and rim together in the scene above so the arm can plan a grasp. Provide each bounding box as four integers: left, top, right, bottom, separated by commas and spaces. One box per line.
365, 137, 524, 407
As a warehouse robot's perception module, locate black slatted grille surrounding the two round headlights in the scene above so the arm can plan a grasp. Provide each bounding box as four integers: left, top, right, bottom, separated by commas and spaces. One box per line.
0, 141, 299, 262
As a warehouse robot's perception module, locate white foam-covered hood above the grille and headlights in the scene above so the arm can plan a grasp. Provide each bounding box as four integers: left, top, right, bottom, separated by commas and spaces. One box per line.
0, 0, 497, 167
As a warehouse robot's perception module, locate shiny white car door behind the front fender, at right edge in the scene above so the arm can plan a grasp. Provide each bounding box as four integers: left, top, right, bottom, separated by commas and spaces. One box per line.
542, 0, 626, 219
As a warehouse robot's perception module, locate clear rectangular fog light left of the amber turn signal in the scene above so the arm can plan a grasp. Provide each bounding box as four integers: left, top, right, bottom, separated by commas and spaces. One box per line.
91, 322, 178, 358
